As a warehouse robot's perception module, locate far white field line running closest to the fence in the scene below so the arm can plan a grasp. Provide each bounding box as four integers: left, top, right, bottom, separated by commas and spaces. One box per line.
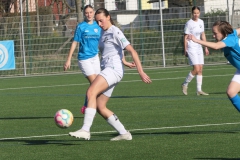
0, 74, 233, 91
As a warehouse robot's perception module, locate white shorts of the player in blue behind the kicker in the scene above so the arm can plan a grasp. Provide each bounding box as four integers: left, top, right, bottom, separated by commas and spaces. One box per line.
78, 54, 101, 77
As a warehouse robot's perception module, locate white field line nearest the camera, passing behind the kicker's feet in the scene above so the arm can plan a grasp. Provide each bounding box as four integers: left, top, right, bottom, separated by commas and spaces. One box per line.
0, 122, 240, 141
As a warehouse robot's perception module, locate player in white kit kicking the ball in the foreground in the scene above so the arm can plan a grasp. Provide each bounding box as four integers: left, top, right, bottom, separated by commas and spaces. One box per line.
69, 8, 151, 141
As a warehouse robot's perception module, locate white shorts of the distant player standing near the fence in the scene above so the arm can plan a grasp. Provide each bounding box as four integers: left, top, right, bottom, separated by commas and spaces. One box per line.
187, 49, 204, 66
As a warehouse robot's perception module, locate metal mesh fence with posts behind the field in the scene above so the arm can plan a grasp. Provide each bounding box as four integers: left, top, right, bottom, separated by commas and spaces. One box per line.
0, 0, 240, 77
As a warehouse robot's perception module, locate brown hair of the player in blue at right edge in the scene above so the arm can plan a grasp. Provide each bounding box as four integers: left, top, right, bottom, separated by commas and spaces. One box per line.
213, 21, 233, 37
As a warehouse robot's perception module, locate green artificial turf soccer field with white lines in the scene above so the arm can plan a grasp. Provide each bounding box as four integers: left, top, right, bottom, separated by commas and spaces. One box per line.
0, 65, 240, 160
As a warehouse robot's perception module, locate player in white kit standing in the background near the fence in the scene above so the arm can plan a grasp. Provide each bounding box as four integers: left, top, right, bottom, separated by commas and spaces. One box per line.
182, 6, 209, 95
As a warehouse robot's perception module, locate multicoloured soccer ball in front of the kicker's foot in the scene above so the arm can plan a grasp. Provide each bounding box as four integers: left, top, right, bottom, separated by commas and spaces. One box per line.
54, 109, 73, 128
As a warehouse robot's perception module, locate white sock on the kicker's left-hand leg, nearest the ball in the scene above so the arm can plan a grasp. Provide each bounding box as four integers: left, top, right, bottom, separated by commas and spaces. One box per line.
82, 108, 96, 132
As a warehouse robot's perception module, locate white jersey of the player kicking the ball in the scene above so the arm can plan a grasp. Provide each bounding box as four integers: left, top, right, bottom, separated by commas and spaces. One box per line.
99, 25, 130, 74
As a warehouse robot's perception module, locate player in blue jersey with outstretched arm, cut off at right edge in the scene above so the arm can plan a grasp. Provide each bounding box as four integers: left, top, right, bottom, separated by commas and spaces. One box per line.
188, 21, 240, 112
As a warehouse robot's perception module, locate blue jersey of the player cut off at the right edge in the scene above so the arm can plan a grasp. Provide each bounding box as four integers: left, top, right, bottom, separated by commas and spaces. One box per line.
222, 30, 240, 70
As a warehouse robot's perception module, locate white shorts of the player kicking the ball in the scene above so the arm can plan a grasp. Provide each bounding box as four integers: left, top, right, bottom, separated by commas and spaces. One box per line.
99, 67, 123, 97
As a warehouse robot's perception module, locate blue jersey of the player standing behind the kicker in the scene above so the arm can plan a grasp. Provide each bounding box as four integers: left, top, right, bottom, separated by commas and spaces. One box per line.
73, 21, 102, 60
